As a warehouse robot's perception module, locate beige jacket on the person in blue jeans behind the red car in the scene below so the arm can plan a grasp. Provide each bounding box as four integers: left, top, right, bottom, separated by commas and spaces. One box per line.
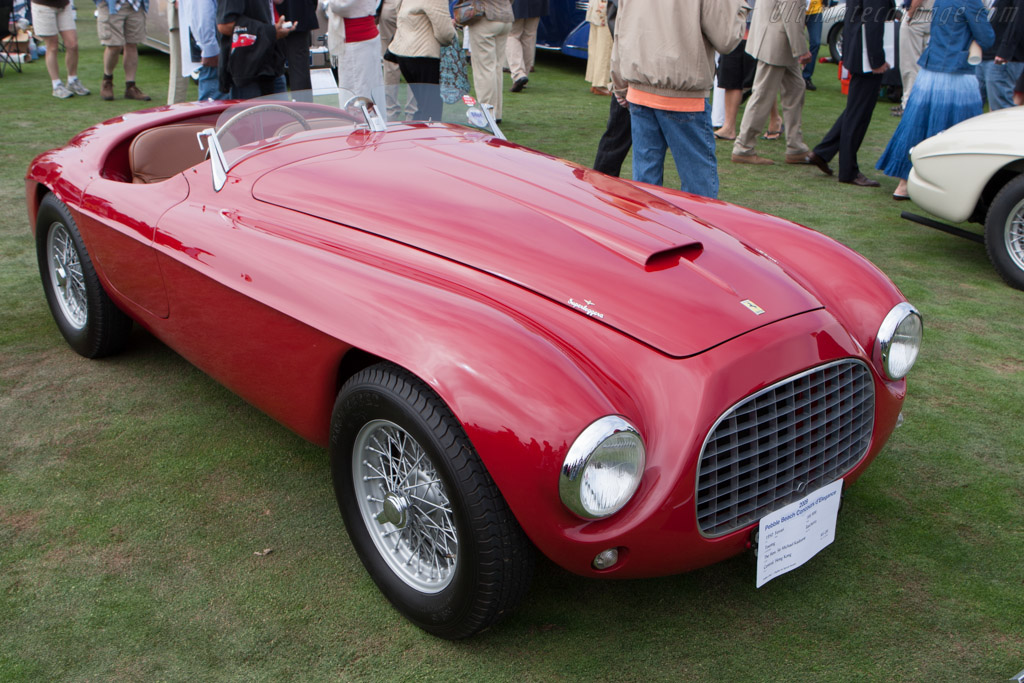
611, 0, 746, 98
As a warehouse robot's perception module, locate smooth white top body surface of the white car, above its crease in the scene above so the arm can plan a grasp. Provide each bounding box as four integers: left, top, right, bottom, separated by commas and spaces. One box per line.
913, 106, 1024, 161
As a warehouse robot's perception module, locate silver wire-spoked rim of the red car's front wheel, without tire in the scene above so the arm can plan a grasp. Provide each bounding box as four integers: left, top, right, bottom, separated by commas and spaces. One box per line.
352, 420, 459, 593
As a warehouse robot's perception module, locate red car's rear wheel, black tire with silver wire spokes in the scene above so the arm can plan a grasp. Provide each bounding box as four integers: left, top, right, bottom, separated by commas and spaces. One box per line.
36, 194, 132, 358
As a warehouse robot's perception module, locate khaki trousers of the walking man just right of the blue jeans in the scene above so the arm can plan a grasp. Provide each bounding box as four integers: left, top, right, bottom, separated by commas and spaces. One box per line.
732, 59, 810, 155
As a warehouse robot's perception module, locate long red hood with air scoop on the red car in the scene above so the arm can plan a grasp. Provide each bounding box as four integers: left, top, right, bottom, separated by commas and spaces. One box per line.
253, 135, 821, 357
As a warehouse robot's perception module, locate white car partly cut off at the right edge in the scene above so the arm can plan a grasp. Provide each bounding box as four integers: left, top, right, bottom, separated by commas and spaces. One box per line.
907, 106, 1024, 290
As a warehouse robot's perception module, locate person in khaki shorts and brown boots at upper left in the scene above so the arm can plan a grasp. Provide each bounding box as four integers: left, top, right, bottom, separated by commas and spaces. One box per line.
96, 0, 152, 101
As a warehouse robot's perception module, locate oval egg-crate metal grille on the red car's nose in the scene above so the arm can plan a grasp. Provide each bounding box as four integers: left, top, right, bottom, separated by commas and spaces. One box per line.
696, 360, 874, 537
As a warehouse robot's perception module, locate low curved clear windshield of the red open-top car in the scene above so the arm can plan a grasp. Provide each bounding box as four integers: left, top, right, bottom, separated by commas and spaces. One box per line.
215, 84, 505, 172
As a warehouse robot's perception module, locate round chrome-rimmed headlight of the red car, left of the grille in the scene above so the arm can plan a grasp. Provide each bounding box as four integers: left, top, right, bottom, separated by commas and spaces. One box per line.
558, 415, 646, 519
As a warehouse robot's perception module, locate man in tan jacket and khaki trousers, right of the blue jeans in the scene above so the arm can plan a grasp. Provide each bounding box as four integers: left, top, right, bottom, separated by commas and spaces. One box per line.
732, 0, 811, 164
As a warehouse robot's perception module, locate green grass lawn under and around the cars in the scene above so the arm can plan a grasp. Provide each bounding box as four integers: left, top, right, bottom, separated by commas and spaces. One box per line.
0, 18, 1024, 681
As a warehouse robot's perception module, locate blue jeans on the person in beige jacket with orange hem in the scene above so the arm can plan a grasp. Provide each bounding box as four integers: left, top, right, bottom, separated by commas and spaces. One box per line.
630, 99, 718, 199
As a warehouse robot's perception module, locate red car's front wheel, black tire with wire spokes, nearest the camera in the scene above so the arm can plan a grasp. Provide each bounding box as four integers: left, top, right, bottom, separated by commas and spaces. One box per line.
330, 364, 535, 640
